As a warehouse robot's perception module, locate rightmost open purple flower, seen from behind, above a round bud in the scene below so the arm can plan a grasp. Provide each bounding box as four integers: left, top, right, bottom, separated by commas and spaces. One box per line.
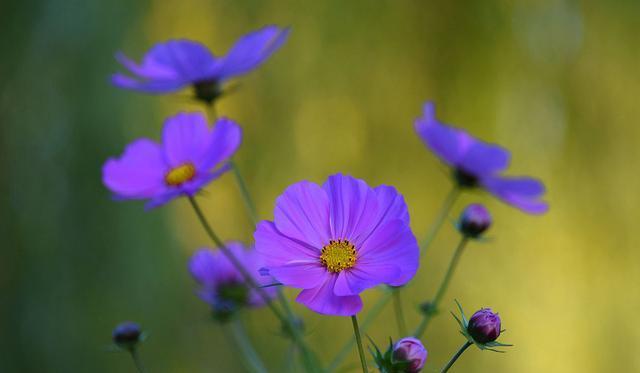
415, 102, 548, 214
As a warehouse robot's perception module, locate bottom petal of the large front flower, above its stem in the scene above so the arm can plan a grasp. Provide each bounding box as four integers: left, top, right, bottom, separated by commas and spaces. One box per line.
296, 275, 362, 316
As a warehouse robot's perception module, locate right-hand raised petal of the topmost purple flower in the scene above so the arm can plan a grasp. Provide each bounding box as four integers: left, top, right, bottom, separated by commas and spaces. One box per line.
219, 26, 289, 80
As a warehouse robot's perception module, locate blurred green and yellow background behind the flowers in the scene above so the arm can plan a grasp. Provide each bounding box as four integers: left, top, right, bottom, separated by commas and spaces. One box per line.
0, 0, 640, 372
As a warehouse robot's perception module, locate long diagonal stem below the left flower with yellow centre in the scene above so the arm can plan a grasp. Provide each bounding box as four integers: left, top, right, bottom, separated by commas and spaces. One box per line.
189, 197, 317, 371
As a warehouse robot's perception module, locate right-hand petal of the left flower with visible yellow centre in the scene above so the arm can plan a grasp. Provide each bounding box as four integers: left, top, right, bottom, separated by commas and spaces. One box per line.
199, 118, 242, 169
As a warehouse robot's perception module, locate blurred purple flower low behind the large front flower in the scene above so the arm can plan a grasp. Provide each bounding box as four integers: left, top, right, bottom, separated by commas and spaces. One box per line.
189, 242, 275, 320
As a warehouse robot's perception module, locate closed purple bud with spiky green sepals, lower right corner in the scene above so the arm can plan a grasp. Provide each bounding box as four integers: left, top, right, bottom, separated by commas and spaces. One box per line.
451, 301, 512, 352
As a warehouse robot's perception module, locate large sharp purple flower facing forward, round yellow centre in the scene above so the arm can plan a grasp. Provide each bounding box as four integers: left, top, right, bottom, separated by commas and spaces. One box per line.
254, 174, 419, 316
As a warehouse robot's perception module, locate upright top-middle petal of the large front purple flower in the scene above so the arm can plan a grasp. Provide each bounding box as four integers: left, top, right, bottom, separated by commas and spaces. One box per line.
323, 174, 378, 247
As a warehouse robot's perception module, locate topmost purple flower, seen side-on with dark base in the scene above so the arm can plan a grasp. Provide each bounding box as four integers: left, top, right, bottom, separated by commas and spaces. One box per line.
111, 26, 289, 103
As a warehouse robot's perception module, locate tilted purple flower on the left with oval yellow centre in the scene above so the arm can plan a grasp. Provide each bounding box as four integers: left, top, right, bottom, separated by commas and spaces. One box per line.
102, 113, 242, 208
